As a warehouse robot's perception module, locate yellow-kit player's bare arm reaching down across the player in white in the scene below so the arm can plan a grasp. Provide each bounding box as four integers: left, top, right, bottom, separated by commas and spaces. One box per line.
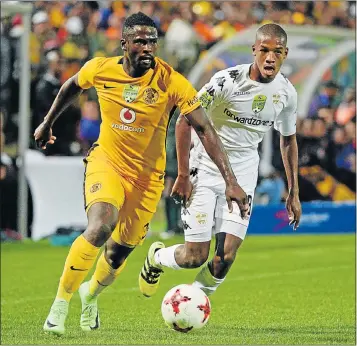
178, 107, 249, 217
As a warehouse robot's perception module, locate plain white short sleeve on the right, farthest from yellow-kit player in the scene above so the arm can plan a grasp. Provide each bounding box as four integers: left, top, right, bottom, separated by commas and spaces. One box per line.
274, 87, 297, 136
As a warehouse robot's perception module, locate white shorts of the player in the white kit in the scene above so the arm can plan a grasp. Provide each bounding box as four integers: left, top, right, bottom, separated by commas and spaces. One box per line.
181, 163, 259, 242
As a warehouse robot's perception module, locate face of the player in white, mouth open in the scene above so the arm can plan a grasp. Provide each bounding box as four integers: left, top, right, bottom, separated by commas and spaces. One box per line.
253, 36, 288, 81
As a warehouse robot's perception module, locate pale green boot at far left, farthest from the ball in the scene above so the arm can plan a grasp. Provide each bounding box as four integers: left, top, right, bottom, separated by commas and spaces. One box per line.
43, 299, 69, 335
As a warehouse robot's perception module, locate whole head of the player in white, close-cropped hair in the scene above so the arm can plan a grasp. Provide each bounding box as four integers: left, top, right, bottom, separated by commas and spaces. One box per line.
252, 24, 288, 81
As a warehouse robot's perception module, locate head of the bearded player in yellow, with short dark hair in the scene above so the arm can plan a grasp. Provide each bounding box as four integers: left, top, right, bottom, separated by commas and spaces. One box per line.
121, 12, 158, 70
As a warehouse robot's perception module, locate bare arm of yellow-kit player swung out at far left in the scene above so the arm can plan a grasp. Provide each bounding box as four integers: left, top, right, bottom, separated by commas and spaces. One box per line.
34, 74, 83, 149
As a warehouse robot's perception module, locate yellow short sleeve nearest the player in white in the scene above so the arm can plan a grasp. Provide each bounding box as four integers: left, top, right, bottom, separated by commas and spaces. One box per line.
171, 71, 200, 115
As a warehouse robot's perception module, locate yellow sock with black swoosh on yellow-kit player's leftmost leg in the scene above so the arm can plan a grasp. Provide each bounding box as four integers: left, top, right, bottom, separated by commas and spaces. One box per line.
56, 235, 100, 302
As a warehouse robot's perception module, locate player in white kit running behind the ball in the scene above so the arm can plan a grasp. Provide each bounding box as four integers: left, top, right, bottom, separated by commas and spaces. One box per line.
139, 24, 301, 296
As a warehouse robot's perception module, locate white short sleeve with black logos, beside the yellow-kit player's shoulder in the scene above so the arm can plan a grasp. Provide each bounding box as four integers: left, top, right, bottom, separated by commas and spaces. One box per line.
197, 71, 229, 111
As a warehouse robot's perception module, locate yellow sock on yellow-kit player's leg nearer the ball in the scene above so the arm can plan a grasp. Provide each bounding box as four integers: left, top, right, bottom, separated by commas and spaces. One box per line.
89, 251, 126, 296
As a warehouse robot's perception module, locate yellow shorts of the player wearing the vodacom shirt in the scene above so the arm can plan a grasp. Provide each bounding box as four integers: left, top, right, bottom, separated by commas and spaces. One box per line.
84, 148, 164, 246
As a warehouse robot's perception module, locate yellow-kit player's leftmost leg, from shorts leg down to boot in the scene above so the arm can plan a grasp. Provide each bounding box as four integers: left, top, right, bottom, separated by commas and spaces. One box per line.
44, 153, 124, 335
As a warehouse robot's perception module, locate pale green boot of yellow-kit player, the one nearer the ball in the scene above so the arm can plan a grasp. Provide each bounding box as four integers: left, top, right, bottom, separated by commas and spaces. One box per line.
79, 281, 100, 332
